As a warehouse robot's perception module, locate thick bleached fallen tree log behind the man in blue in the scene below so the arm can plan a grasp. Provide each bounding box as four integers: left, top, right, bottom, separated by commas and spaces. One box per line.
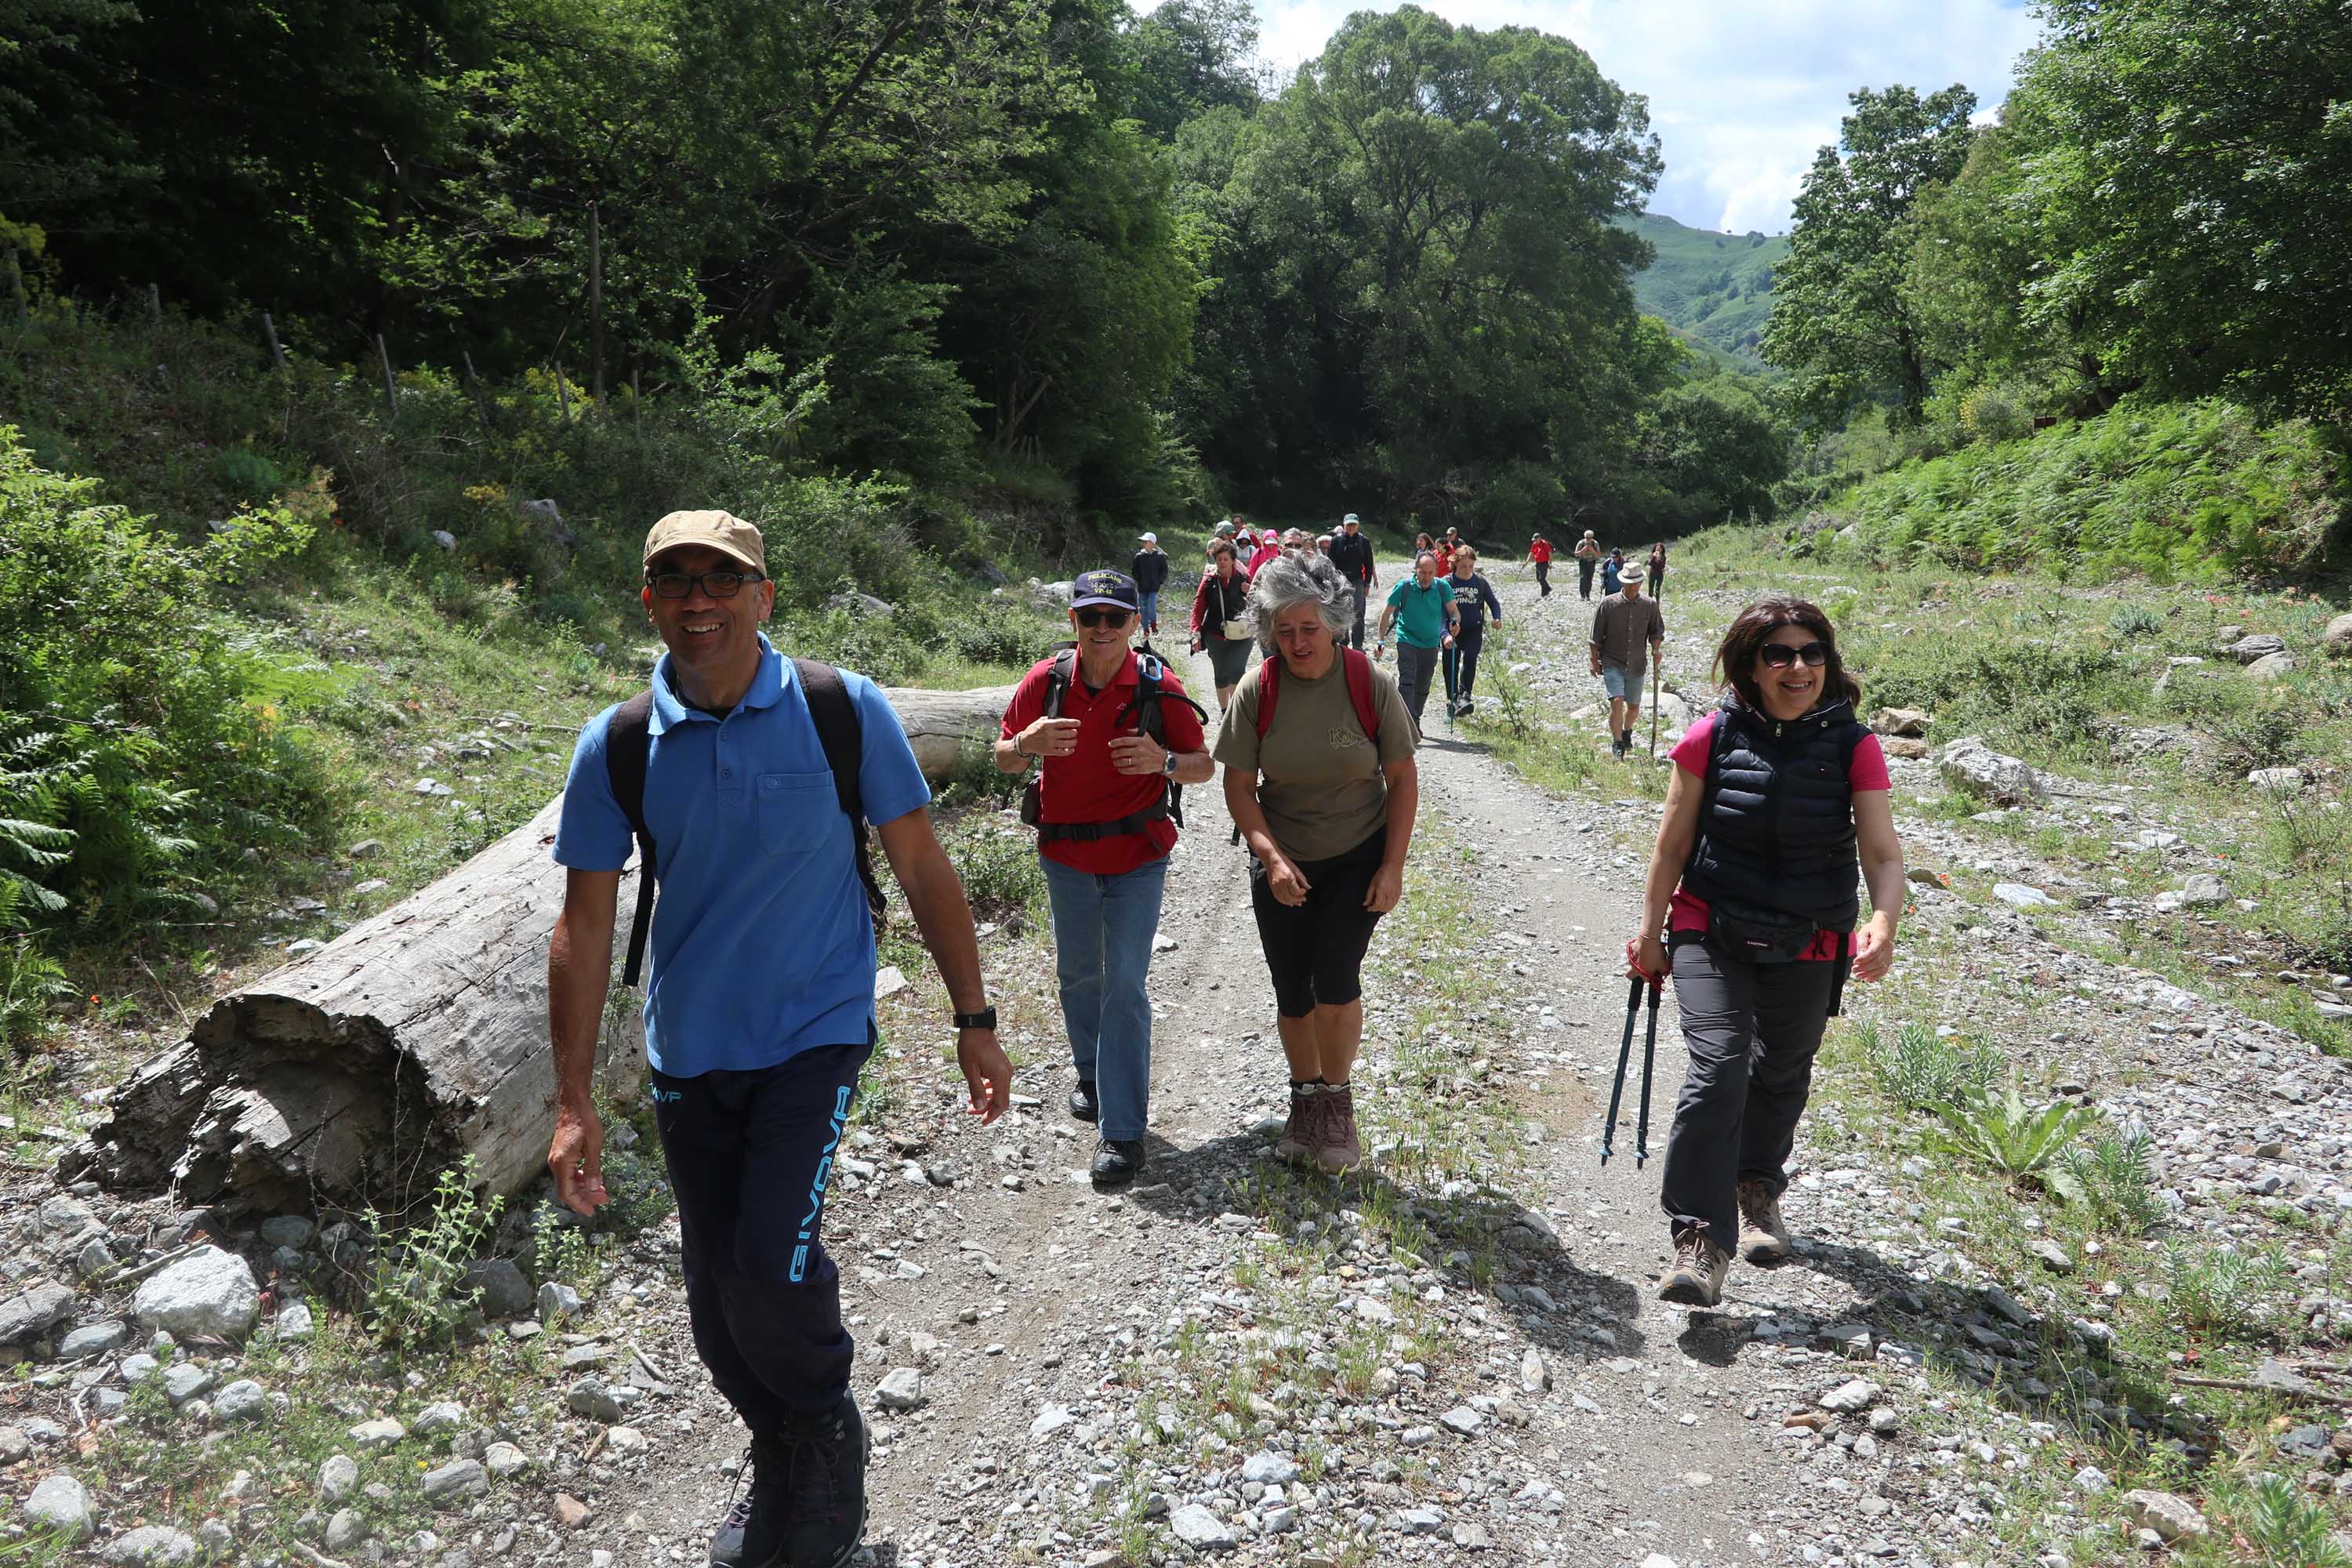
59, 687, 1011, 1215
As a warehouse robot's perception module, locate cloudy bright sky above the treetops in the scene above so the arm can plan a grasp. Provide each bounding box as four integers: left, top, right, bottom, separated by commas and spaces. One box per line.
1258, 0, 2037, 233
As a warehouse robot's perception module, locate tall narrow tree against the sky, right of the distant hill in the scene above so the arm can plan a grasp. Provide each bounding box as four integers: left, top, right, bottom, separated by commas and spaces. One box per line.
1762, 85, 1976, 428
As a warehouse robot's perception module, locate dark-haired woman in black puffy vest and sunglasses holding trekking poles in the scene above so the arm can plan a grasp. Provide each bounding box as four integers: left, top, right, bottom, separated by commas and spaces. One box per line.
1625, 595, 1903, 1307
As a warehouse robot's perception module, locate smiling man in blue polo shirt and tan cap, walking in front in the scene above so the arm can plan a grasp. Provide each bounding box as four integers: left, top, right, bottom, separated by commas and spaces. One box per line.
548, 513, 1011, 1568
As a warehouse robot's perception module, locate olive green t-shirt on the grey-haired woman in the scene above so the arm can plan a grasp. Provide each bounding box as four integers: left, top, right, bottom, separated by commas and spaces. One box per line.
1216, 654, 1414, 860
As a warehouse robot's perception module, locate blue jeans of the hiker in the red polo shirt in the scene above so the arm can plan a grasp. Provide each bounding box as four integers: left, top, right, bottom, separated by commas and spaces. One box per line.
1042, 855, 1169, 1142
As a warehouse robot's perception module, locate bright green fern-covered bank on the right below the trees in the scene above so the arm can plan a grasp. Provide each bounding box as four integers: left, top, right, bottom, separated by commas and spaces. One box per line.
1816, 400, 2345, 581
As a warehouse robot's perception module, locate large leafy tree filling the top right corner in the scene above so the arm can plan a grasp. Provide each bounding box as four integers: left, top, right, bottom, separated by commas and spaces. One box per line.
2023, 0, 2352, 421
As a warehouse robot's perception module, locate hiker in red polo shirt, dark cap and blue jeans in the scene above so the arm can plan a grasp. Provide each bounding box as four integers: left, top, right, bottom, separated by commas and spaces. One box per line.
995, 572, 1216, 1187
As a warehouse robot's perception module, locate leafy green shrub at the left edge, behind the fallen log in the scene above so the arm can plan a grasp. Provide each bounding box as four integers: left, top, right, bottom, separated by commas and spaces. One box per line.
0, 426, 325, 933
